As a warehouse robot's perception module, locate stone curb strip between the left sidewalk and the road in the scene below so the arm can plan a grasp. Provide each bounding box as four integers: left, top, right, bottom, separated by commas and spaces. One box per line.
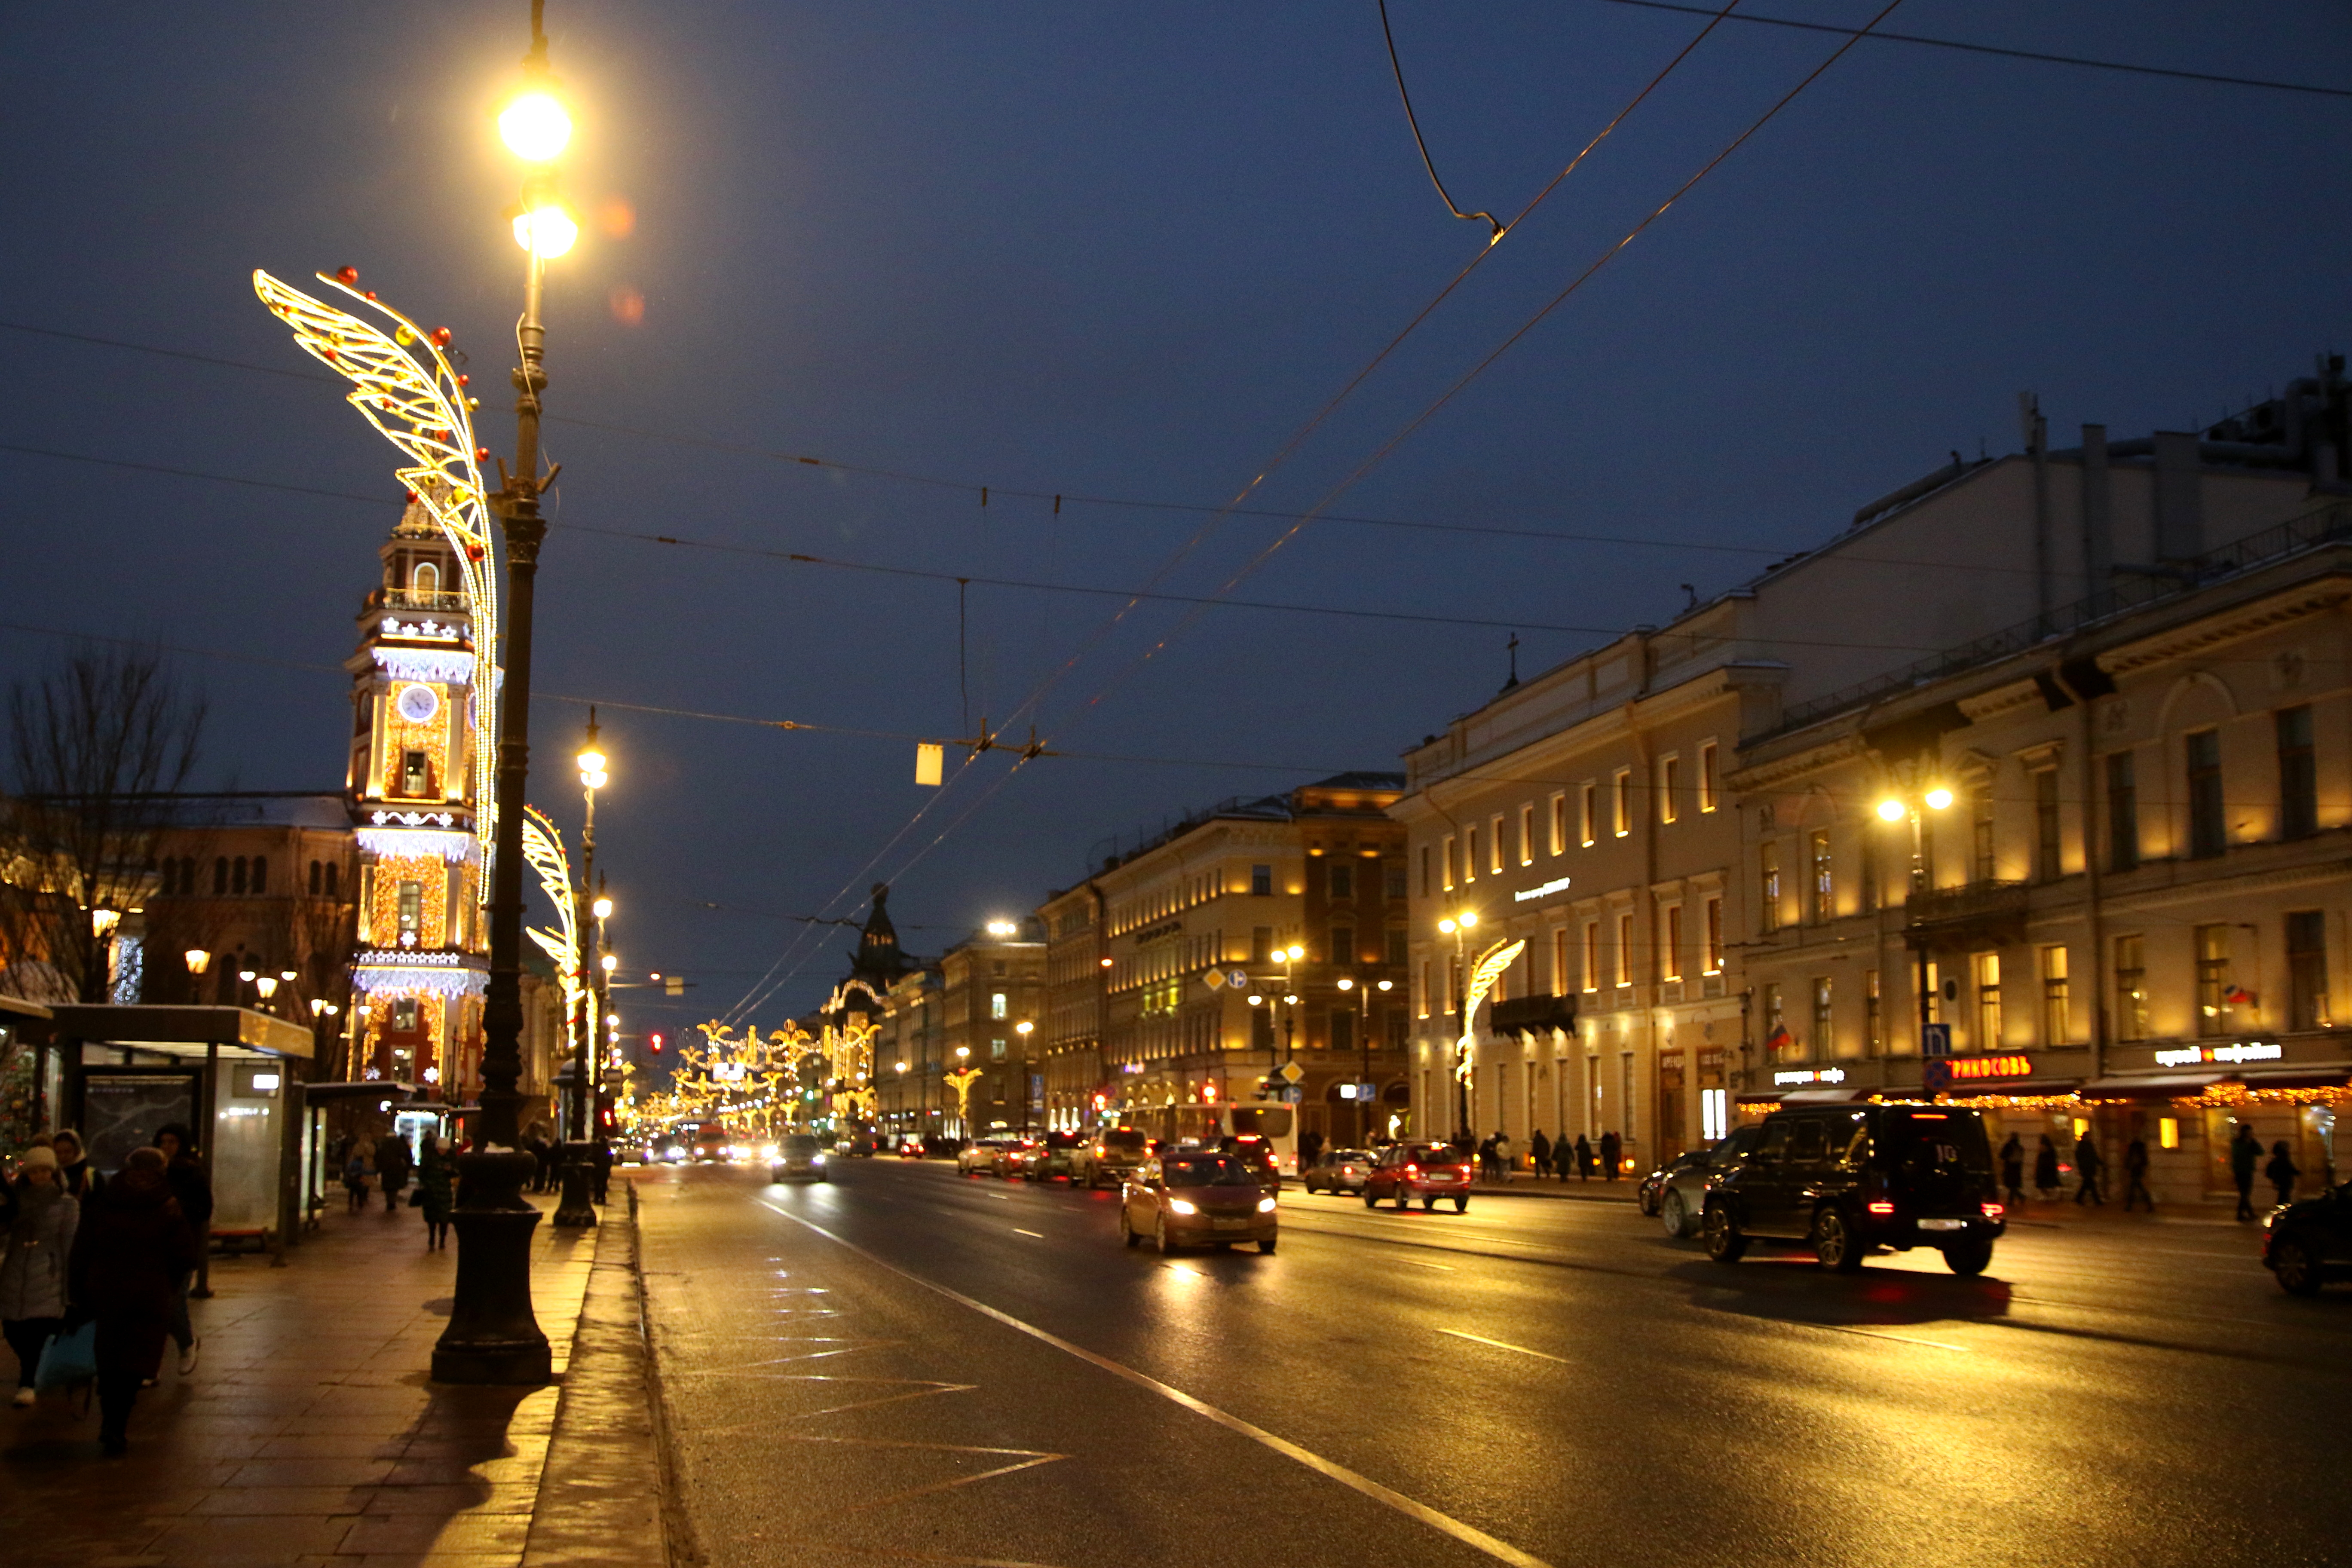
522, 1185, 673, 1568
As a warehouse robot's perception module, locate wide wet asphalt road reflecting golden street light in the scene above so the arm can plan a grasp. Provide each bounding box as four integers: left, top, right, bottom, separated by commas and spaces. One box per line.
637, 1161, 2352, 1568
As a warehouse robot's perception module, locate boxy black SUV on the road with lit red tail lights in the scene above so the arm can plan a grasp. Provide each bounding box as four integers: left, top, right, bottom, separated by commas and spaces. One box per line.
1700, 1105, 2006, 1274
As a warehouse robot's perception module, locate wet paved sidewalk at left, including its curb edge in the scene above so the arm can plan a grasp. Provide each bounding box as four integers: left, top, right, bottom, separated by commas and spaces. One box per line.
0, 1187, 663, 1568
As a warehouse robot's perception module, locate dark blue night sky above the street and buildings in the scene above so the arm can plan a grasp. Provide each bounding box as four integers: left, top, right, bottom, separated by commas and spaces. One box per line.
0, 0, 2352, 1032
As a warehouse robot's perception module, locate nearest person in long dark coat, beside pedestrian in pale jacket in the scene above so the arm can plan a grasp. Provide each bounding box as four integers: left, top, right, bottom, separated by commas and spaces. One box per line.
66, 1149, 195, 1453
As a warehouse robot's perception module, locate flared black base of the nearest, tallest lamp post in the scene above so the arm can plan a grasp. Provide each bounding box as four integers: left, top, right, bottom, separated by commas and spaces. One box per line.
433, 1154, 553, 1387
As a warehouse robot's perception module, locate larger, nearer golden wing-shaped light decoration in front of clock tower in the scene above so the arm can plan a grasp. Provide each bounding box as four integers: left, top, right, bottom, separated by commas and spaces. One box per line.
254, 268, 499, 884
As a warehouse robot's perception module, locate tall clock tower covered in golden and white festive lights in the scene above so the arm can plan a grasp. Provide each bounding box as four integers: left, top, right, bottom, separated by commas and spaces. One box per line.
343, 501, 489, 1105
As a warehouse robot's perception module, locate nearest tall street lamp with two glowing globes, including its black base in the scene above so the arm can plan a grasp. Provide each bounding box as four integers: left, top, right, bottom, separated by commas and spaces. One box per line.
433, 0, 579, 1384
